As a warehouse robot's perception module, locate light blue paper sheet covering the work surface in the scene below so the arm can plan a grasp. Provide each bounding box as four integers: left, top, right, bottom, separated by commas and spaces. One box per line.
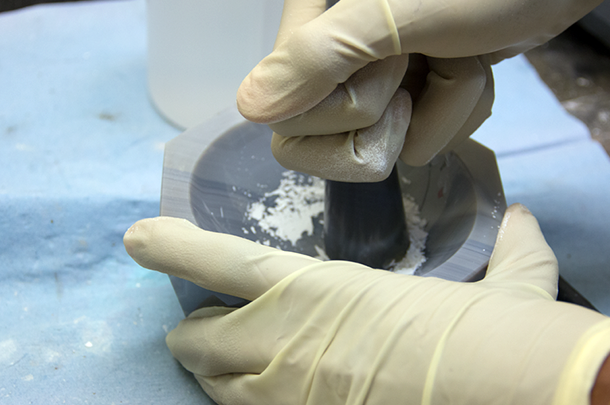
0, 0, 610, 404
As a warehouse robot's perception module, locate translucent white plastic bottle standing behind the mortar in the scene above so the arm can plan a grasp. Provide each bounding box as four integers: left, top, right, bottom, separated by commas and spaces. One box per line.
147, 0, 283, 129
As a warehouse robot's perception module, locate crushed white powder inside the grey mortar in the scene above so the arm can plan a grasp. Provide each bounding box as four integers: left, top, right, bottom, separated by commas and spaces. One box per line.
244, 170, 428, 274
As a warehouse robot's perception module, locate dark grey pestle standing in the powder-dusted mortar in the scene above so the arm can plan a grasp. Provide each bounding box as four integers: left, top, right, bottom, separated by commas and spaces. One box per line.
324, 0, 409, 269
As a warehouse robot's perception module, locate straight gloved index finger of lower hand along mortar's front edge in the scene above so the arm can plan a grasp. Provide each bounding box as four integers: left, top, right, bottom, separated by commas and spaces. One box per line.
123, 217, 320, 300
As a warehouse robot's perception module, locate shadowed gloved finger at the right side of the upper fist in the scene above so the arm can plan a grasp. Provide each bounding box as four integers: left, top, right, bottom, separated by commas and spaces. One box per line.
400, 57, 493, 166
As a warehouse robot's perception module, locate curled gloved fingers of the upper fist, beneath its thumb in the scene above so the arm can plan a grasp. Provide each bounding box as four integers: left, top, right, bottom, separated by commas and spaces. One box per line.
269, 54, 494, 182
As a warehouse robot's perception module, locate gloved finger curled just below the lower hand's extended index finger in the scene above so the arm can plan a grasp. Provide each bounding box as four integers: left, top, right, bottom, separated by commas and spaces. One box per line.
166, 262, 328, 377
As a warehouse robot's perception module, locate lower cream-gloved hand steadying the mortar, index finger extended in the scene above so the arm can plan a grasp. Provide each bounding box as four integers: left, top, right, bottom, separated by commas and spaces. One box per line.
125, 205, 610, 405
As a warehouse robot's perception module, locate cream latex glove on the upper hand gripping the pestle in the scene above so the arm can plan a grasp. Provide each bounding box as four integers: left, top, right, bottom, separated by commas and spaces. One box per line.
237, 0, 601, 181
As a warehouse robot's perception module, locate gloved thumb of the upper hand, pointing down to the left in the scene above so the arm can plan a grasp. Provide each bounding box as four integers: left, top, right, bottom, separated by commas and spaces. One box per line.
237, 0, 402, 124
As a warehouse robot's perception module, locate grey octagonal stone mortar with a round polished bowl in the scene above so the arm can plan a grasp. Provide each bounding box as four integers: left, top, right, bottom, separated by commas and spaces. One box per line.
161, 108, 506, 314
